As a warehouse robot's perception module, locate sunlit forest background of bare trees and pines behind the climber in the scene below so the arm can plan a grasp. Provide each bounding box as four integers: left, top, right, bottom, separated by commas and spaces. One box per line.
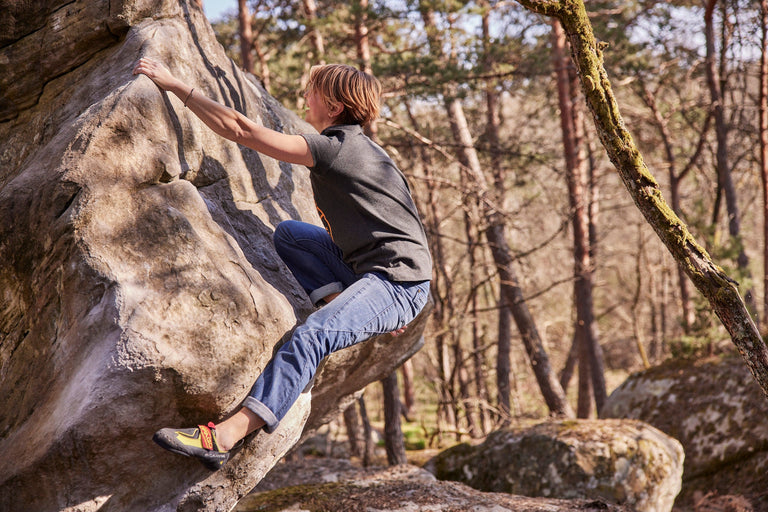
200, 0, 768, 463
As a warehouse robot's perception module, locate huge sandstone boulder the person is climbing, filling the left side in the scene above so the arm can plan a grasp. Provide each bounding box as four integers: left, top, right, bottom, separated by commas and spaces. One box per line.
0, 0, 425, 512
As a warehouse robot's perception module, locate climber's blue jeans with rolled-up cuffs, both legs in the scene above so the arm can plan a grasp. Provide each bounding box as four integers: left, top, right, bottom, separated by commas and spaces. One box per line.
243, 221, 429, 432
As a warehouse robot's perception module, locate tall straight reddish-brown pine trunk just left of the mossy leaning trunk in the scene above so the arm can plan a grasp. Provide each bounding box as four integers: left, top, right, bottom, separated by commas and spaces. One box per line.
552, 19, 608, 418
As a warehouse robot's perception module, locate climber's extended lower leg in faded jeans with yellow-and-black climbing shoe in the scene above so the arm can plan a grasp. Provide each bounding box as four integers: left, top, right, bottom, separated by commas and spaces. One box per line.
153, 273, 429, 470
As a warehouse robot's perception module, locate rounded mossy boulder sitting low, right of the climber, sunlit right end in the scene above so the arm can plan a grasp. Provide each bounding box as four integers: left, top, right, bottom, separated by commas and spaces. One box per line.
426, 420, 683, 512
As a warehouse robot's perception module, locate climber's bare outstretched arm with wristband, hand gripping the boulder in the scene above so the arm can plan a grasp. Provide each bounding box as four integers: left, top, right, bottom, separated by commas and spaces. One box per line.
133, 58, 314, 167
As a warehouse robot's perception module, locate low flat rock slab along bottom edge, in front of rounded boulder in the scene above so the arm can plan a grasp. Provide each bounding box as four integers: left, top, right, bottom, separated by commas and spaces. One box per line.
235, 459, 630, 512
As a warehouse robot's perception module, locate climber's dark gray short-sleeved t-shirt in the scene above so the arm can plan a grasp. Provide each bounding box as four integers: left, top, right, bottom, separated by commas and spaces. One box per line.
303, 125, 432, 281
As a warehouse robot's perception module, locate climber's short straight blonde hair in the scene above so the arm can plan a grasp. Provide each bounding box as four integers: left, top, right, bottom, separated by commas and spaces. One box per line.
307, 64, 381, 126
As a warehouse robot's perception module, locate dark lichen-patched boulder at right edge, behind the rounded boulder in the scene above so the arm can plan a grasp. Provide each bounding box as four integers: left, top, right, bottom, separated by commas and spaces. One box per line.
600, 354, 768, 508
